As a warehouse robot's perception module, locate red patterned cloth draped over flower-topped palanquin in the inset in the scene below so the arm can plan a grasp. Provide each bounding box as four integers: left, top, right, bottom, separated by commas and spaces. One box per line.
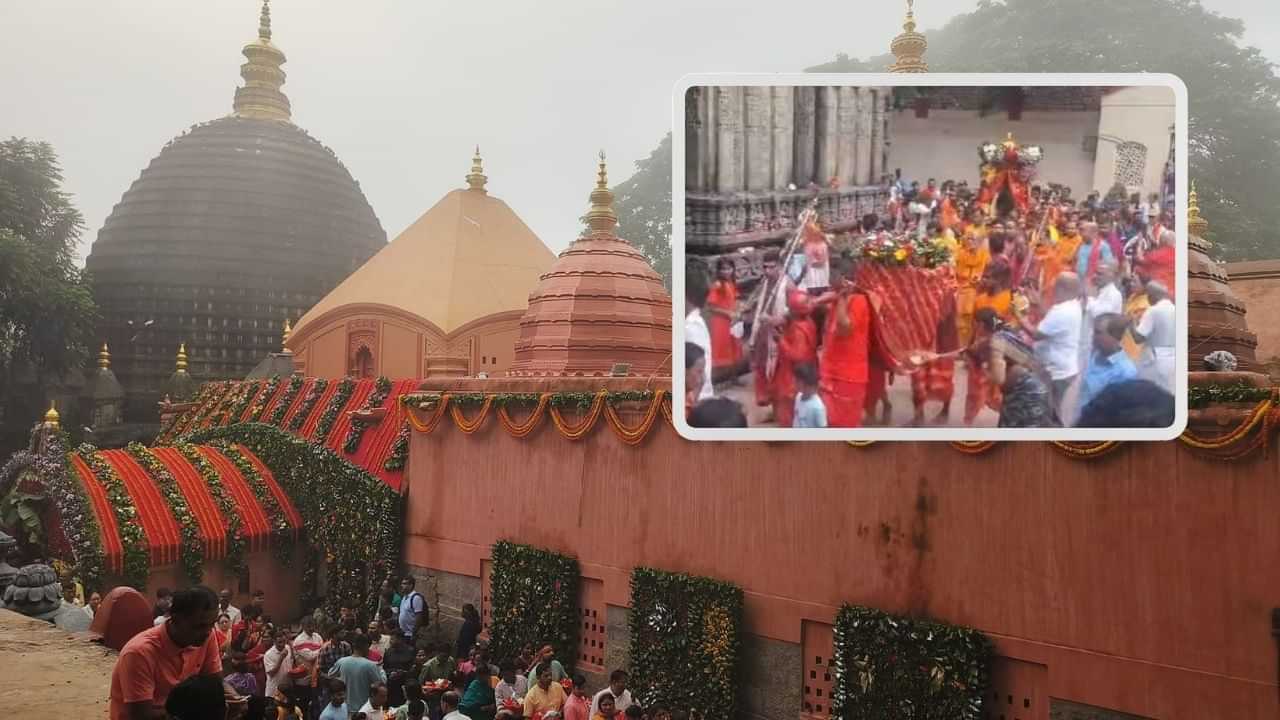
855, 263, 956, 373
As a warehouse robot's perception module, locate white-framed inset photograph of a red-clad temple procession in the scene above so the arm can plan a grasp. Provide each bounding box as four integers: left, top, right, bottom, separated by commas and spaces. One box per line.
675, 76, 1182, 439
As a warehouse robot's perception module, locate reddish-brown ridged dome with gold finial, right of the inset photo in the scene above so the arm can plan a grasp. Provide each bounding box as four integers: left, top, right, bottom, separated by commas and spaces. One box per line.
1187, 184, 1258, 370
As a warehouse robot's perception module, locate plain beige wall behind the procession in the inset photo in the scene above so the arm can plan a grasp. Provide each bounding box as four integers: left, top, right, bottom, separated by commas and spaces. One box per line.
886, 110, 1095, 199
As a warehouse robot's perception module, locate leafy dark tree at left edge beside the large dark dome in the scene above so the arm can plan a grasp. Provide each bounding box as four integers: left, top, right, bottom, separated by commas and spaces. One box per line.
0, 138, 97, 382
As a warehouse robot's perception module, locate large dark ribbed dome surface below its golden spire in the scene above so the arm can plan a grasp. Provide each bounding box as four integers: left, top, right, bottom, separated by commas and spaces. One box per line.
87, 115, 387, 416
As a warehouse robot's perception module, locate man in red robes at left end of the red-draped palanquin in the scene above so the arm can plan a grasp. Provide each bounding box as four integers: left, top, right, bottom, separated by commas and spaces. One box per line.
818, 258, 872, 428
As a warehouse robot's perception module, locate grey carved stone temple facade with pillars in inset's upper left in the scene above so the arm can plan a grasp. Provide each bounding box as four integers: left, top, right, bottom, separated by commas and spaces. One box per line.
685, 87, 892, 272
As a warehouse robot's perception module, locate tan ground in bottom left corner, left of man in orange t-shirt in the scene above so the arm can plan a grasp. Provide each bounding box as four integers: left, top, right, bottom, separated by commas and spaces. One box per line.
0, 610, 116, 717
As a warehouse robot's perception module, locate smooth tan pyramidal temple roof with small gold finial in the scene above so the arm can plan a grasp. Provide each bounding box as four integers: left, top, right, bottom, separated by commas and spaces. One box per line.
293, 149, 556, 337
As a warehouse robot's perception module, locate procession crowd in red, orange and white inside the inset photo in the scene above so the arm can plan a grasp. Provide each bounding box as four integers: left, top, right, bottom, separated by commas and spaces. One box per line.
685, 174, 1176, 428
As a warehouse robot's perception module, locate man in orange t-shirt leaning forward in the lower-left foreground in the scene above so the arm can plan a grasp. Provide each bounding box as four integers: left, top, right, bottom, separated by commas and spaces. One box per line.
110, 587, 237, 720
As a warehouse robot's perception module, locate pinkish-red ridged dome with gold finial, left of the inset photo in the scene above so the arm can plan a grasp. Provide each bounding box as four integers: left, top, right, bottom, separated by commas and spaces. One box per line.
508, 154, 671, 377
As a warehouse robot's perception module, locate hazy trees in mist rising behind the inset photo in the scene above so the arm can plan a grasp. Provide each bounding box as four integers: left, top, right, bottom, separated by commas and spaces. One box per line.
627, 0, 1280, 260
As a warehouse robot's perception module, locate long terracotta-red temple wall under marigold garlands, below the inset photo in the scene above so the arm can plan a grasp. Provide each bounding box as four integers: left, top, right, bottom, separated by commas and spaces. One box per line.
404, 383, 1280, 719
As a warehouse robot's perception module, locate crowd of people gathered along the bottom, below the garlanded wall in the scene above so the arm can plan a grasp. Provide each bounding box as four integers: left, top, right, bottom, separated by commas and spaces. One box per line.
110, 577, 687, 720
